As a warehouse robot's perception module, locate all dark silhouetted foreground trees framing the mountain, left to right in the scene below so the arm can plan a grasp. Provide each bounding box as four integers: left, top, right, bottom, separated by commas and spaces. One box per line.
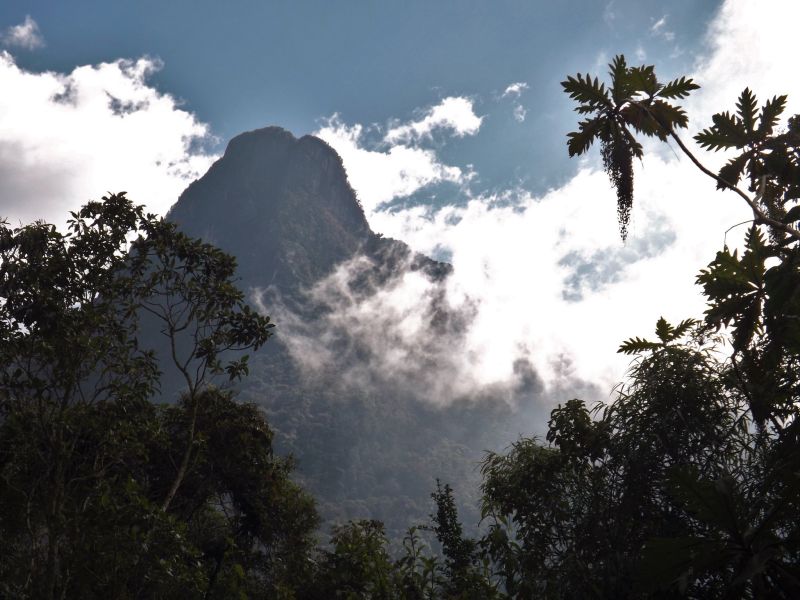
0, 56, 800, 599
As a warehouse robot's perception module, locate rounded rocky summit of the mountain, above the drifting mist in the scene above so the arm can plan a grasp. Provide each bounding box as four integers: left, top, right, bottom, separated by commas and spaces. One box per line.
168, 127, 375, 290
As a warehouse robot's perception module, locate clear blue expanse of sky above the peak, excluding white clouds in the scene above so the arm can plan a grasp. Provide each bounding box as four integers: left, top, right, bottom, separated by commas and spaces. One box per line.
0, 0, 718, 196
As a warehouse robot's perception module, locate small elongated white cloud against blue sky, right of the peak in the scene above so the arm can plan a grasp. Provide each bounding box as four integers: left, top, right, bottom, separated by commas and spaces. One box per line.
384, 96, 483, 144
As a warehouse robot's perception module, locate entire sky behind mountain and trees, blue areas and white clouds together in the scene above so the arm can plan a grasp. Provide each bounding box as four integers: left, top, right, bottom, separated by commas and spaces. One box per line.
0, 0, 800, 400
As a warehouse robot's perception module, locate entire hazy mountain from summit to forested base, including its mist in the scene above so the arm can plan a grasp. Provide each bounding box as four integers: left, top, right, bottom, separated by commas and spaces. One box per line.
162, 127, 586, 534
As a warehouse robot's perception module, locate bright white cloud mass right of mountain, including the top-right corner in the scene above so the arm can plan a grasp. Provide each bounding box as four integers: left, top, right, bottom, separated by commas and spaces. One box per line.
310, 0, 800, 404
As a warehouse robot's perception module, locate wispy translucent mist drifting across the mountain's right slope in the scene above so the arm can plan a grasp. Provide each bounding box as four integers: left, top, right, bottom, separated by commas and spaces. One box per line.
260, 233, 599, 408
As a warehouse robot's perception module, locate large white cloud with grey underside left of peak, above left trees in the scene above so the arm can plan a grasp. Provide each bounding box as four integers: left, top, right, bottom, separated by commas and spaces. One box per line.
0, 53, 213, 224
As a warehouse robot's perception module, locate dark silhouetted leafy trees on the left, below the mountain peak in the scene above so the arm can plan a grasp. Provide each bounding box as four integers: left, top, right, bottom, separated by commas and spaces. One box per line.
0, 194, 316, 598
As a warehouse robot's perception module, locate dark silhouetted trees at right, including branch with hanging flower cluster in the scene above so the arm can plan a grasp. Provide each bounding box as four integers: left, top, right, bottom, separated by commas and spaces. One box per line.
466, 57, 800, 598
